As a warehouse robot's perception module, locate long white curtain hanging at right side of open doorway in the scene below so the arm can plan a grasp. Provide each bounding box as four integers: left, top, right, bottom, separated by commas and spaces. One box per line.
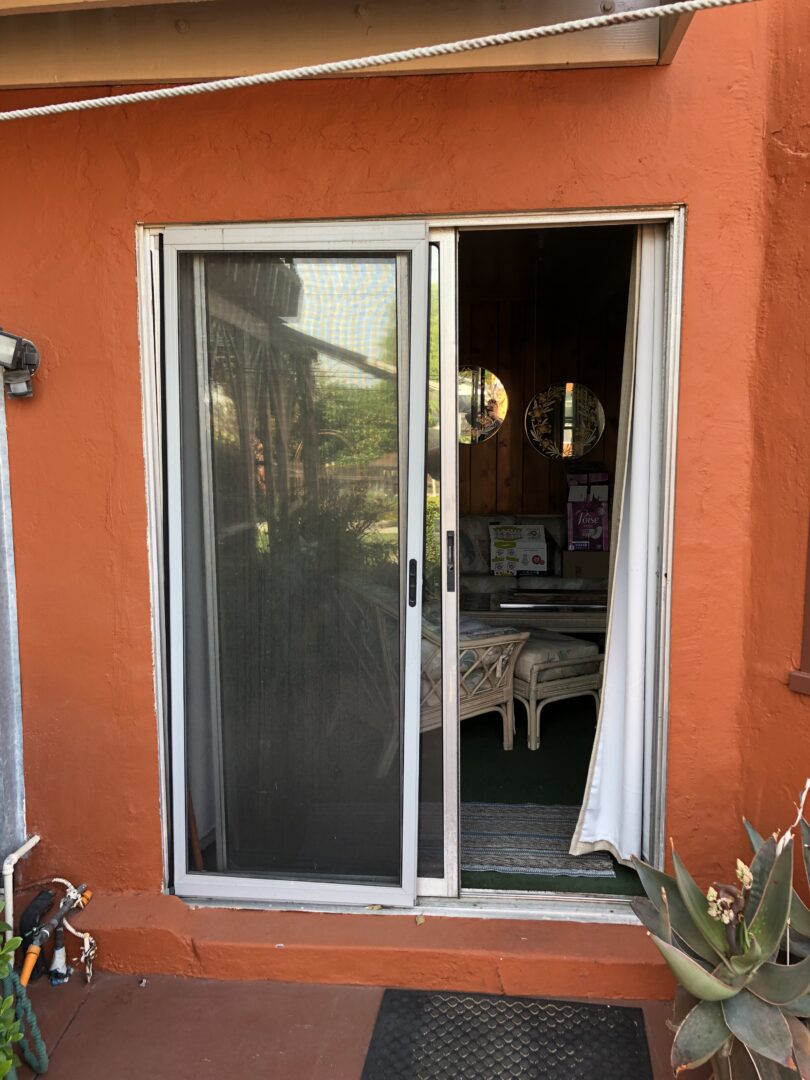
570, 226, 666, 862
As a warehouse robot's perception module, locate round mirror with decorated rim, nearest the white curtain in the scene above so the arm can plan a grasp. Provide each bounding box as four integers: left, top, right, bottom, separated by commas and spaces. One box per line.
526, 382, 605, 461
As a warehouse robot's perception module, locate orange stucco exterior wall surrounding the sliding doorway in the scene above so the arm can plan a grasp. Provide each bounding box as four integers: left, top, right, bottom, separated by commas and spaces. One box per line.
0, 0, 810, 997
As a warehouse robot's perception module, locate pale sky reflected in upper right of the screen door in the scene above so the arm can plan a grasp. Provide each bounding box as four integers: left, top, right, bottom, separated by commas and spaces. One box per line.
285, 256, 396, 377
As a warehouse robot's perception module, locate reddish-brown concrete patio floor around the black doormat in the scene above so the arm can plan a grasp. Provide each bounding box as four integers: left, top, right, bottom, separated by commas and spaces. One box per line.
18, 972, 672, 1080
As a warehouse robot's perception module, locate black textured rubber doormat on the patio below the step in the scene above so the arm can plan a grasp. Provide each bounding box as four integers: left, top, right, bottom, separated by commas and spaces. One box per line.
362, 990, 652, 1080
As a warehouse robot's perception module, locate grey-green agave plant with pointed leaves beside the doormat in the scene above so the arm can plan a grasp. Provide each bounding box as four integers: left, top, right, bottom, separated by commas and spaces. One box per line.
633, 785, 810, 1080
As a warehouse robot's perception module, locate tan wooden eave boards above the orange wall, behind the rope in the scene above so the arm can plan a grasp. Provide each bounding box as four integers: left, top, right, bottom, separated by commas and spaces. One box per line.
0, 0, 679, 87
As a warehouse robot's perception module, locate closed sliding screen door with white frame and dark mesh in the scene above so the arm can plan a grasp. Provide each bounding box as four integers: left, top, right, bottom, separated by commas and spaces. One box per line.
164, 222, 428, 904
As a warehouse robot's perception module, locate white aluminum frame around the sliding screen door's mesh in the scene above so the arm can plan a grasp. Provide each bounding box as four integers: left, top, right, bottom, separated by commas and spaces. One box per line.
163, 220, 428, 906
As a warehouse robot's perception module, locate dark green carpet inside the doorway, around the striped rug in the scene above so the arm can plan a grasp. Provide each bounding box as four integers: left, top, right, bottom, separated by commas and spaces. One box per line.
461, 698, 643, 896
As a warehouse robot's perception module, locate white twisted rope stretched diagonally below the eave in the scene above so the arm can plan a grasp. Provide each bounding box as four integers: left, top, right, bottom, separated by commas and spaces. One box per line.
0, 0, 754, 121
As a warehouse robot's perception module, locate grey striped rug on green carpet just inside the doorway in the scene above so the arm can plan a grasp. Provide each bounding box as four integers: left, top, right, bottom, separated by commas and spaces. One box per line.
461, 802, 616, 878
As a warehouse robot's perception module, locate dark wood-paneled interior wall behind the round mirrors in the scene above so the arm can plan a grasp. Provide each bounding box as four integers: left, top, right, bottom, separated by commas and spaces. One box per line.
459, 226, 633, 514
